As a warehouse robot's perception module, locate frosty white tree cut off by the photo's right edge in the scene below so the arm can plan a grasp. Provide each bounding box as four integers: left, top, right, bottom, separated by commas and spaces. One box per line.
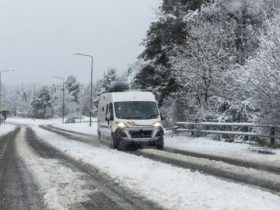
243, 10, 280, 124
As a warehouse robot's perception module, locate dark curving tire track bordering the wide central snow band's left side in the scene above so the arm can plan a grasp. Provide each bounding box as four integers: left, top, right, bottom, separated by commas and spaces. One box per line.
26, 128, 161, 210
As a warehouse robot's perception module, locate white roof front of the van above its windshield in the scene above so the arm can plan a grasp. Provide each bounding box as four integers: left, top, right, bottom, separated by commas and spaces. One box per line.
103, 91, 156, 102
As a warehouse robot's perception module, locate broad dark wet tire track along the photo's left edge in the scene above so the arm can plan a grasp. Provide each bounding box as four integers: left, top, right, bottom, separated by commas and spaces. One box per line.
0, 128, 44, 210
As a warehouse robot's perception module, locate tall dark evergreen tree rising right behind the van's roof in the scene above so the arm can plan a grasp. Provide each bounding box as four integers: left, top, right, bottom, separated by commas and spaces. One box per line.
134, 0, 211, 105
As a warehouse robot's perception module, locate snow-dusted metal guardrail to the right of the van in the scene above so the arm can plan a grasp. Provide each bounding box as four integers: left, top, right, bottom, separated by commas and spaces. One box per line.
170, 122, 280, 145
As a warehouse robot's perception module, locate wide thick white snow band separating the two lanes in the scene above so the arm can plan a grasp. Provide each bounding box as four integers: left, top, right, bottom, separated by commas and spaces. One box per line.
33, 124, 280, 210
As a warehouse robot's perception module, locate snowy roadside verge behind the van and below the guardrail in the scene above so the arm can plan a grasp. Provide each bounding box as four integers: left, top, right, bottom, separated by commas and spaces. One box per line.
49, 120, 280, 167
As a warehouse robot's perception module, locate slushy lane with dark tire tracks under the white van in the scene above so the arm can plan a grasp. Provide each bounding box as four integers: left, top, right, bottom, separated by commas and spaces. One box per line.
42, 126, 280, 193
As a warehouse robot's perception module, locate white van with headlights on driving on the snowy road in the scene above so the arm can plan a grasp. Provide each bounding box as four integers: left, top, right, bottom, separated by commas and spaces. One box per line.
97, 91, 164, 149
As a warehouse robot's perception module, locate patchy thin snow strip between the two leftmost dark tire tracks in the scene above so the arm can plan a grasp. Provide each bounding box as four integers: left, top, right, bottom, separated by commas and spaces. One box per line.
16, 131, 92, 210
